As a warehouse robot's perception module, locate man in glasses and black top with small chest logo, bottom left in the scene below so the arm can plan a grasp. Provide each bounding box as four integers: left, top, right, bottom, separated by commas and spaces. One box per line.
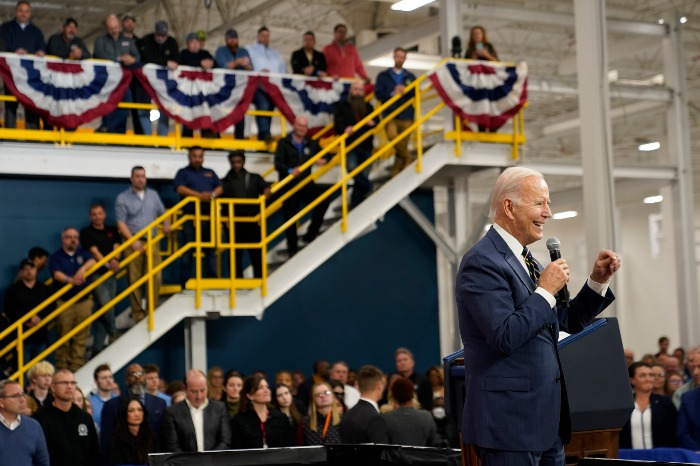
33, 369, 100, 466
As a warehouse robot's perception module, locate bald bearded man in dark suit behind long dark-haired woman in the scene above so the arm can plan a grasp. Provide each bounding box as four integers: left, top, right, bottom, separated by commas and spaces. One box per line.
100, 363, 166, 458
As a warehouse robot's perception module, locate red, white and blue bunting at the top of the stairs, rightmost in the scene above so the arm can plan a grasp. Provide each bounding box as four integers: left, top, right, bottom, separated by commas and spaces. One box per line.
428, 60, 527, 131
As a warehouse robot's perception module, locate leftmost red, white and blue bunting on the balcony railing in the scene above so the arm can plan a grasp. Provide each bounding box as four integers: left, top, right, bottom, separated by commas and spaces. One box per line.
0, 53, 131, 129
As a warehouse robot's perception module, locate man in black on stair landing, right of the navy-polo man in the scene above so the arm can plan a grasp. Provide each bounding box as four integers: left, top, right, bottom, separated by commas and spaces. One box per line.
221, 151, 271, 278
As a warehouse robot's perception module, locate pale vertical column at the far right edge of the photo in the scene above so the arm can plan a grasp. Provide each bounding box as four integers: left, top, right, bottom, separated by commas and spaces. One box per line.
662, 14, 700, 347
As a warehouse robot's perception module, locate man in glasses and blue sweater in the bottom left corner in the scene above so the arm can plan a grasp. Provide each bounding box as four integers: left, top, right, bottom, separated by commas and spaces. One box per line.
0, 380, 49, 466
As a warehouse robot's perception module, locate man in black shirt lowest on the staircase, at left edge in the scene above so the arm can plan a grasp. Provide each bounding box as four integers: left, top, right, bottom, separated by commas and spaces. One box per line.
2, 259, 55, 363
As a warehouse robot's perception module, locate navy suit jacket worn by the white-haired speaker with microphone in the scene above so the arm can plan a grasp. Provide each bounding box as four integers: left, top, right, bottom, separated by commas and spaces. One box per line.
455, 227, 614, 451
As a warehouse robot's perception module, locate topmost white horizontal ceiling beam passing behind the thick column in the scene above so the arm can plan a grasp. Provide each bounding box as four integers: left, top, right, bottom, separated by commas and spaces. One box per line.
462, 4, 668, 37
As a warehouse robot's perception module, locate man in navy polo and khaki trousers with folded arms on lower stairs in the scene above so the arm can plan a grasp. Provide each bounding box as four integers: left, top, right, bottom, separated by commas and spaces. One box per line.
49, 227, 95, 372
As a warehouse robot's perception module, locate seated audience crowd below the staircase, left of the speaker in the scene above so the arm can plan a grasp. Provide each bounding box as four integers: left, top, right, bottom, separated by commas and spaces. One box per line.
0, 348, 458, 466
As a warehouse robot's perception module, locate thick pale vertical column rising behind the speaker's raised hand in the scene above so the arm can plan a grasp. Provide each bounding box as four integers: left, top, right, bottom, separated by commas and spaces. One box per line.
574, 0, 621, 302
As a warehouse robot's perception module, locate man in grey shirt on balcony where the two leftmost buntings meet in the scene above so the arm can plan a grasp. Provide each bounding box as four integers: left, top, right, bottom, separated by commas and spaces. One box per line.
93, 14, 141, 134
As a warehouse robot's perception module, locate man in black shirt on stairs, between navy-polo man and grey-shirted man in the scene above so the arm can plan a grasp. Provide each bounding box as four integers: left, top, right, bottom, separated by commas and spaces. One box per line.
80, 204, 121, 356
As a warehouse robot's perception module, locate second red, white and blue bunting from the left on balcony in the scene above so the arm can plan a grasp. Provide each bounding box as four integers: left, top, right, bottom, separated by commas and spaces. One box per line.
134, 64, 261, 131
